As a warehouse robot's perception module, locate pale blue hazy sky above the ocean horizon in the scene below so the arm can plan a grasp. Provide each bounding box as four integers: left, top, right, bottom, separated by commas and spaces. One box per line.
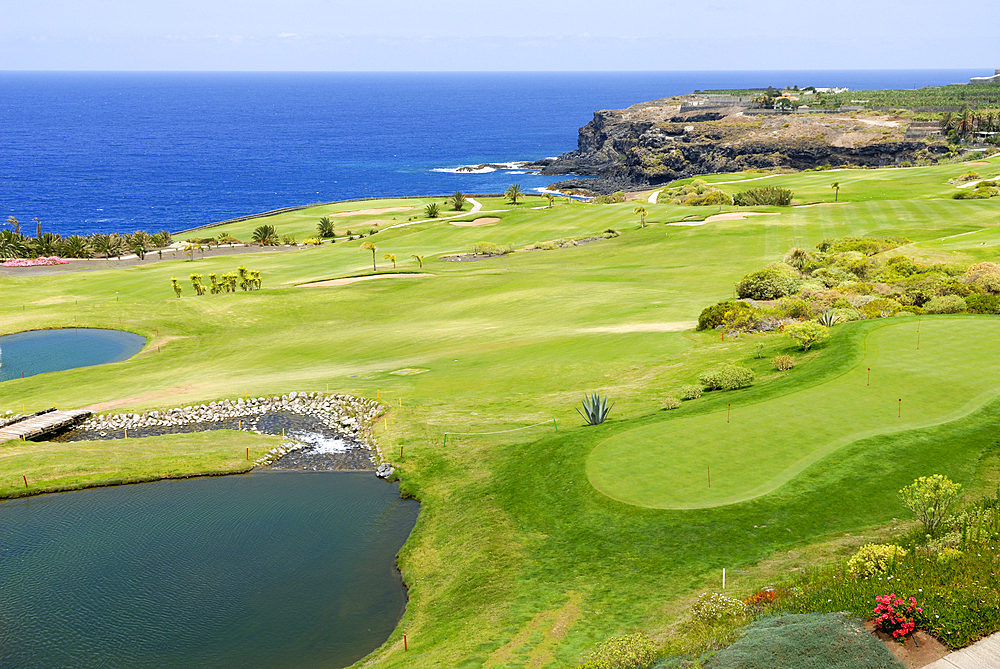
0, 0, 1000, 74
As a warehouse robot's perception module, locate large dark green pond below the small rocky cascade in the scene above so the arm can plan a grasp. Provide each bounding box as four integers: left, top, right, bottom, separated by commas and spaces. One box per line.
0, 470, 419, 669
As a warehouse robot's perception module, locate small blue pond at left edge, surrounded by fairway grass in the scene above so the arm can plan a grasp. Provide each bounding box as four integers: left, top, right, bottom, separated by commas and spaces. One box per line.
0, 328, 146, 381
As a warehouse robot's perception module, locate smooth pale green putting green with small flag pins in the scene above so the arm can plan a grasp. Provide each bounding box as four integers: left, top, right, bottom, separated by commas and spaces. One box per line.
587, 316, 1000, 509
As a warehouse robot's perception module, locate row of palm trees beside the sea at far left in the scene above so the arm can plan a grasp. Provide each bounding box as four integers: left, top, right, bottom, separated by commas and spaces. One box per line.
0, 216, 170, 259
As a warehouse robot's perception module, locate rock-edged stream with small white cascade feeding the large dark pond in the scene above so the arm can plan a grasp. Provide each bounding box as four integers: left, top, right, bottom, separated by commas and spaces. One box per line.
47, 392, 392, 478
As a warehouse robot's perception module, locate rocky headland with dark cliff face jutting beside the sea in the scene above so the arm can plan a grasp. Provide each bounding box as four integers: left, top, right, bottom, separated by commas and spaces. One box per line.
541, 105, 945, 194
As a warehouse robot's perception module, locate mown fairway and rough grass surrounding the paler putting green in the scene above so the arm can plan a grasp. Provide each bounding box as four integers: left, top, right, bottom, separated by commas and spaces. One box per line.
0, 155, 1000, 667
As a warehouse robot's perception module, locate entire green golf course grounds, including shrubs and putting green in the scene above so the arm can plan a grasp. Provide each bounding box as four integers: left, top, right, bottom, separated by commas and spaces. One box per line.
0, 158, 1000, 668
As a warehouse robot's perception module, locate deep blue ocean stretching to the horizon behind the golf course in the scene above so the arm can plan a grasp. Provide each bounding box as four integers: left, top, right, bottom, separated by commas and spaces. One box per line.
0, 70, 983, 235
